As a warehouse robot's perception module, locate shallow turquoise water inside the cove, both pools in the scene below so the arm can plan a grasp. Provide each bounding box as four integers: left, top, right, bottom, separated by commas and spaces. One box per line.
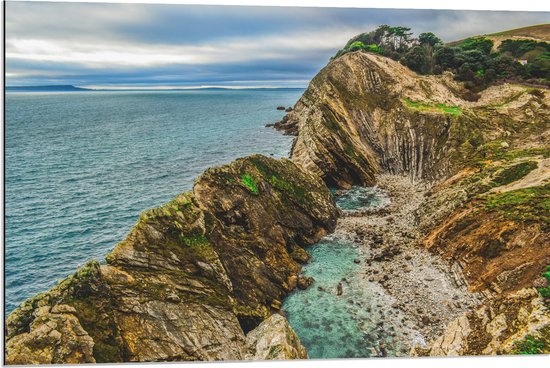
283, 187, 409, 359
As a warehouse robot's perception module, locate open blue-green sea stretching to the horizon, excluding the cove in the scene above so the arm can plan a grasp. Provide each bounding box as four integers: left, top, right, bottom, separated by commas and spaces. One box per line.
5, 90, 303, 312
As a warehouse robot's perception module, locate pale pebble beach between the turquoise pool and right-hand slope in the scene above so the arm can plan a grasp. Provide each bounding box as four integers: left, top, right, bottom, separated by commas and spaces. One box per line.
336, 175, 482, 345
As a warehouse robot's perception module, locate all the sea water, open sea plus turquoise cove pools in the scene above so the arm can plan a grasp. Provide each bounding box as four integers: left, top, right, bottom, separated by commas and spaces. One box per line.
5, 89, 404, 358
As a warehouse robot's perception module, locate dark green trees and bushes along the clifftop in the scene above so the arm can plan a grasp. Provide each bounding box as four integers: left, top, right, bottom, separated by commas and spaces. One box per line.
334, 25, 550, 93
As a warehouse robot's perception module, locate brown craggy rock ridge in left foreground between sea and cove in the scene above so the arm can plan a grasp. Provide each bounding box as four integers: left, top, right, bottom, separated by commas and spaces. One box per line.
6, 156, 338, 364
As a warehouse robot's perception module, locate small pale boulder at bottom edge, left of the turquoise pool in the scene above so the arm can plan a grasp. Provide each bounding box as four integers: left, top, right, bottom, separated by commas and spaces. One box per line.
246, 314, 307, 360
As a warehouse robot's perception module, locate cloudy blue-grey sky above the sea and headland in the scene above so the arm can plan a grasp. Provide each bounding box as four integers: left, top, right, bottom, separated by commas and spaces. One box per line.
5, 1, 550, 88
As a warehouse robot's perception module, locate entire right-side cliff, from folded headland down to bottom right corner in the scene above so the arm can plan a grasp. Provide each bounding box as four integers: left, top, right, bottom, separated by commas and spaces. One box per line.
277, 52, 550, 355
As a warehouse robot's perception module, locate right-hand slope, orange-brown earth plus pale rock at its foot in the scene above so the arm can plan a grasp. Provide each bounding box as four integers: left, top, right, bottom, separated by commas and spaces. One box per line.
413, 123, 550, 356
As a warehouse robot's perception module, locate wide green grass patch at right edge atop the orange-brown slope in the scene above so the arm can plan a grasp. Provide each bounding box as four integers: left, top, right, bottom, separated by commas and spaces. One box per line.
486, 184, 550, 227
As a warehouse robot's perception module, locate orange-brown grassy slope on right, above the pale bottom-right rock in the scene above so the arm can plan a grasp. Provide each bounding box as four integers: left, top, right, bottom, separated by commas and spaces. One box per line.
419, 151, 550, 294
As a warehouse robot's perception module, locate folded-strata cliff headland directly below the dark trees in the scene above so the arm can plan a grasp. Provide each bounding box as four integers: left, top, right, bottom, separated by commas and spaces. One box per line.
278, 52, 542, 188
